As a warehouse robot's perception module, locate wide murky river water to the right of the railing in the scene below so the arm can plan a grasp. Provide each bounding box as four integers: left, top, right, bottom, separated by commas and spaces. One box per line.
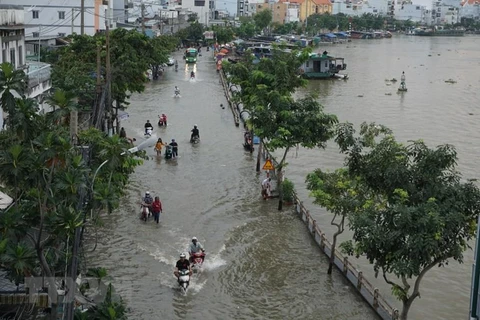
287, 36, 480, 320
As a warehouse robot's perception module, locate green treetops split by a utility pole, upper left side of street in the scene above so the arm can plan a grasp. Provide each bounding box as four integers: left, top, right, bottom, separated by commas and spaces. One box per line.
49, 28, 178, 109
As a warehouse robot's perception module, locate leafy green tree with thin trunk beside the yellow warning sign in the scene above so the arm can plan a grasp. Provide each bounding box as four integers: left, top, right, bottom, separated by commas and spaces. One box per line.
225, 48, 337, 210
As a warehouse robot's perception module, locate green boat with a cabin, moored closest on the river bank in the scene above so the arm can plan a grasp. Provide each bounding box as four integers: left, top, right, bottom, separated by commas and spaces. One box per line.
300, 51, 348, 79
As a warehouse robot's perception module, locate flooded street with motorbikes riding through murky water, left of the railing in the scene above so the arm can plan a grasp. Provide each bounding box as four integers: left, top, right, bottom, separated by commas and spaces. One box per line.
89, 52, 376, 320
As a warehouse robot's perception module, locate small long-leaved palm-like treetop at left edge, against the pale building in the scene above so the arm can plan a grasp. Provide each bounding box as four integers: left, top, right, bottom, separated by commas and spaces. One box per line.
0, 62, 27, 125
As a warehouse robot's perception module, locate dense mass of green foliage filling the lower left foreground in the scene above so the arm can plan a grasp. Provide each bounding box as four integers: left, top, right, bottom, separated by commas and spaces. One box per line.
0, 64, 141, 290
